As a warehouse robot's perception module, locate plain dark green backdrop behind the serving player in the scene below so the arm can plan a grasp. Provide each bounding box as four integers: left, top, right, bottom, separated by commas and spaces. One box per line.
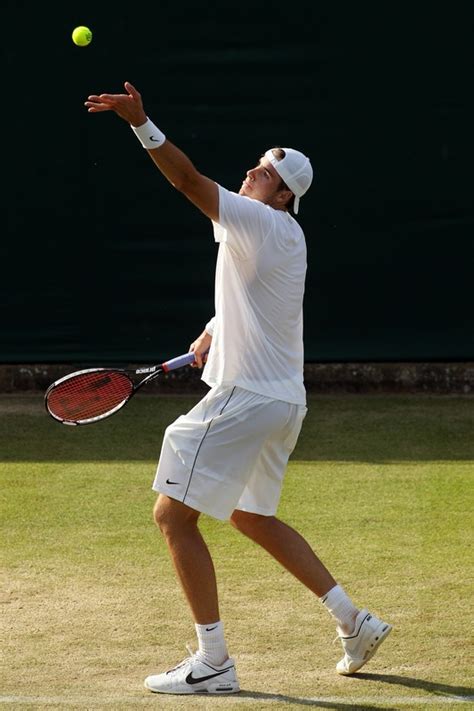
4, 0, 474, 363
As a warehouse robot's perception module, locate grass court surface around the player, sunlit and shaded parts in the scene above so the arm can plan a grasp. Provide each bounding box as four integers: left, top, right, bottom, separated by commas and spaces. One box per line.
0, 395, 474, 711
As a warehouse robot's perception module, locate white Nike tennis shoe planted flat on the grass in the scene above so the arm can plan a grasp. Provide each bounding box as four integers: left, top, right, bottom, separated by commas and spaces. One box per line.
145, 650, 240, 694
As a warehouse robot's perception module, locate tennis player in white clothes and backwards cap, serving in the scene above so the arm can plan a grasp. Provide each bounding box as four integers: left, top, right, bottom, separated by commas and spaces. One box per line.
85, 82, 391, 694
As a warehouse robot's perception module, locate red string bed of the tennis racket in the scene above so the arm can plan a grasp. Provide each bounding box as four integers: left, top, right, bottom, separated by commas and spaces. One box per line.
48, 371, 133, 422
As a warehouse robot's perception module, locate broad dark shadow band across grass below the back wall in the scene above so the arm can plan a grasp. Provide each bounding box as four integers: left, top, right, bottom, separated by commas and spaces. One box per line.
0, 396, 474, 462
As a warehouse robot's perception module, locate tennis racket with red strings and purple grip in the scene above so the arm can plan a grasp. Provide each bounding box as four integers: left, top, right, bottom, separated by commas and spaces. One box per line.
44, 353, 198, 425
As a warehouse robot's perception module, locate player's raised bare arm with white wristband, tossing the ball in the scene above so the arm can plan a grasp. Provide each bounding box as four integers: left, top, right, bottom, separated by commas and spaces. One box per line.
85, 82, 219, 220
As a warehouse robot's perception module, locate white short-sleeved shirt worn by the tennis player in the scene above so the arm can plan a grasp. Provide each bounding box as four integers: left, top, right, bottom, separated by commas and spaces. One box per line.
202, 186, 306, 405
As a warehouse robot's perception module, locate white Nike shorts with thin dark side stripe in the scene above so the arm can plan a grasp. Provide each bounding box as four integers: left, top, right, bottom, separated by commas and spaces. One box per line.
153, 386, 307, 520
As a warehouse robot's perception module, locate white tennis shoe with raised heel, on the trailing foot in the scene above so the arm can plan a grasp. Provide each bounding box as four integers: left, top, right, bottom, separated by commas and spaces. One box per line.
336, 610, 392, 676
